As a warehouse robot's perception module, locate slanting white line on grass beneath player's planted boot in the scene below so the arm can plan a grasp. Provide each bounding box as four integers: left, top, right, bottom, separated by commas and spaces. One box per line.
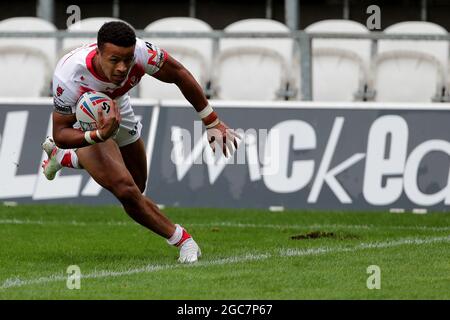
0, 236, 450, 290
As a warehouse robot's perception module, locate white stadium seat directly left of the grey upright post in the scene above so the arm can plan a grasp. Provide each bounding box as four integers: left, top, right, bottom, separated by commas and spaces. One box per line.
213, 19, 293, 101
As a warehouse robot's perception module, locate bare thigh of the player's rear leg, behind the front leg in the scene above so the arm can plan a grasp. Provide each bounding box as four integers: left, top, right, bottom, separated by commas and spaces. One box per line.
120, 138, 147, 192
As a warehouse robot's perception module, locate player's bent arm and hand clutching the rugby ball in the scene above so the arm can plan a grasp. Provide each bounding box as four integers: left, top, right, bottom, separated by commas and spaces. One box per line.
53, 101, 121, 149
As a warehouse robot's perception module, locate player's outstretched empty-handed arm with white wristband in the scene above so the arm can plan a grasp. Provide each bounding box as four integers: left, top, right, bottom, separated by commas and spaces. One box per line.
153, 55, 240, 156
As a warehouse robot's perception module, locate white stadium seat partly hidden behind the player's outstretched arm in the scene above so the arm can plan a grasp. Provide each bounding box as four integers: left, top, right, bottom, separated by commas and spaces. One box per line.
139, 17, 213, 99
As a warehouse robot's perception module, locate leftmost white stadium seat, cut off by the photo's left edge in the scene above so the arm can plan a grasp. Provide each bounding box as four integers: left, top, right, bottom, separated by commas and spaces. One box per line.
0, 17, 57, 97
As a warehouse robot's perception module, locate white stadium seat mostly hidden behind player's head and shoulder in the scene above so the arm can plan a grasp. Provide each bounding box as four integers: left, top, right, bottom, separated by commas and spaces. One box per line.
59, 17, 122, 57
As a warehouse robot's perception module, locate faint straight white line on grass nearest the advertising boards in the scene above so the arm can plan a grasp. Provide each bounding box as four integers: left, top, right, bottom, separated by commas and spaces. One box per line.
0, 218, 450, 232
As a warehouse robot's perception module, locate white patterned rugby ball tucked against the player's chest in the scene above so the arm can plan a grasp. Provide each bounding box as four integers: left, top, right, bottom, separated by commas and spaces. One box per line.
75, 91, 112, 131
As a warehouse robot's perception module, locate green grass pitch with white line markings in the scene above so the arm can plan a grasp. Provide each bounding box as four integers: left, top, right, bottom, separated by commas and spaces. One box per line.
0, 205, 450, 300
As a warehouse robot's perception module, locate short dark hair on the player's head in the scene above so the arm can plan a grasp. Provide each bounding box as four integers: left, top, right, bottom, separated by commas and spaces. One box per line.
97, 21, 136, 49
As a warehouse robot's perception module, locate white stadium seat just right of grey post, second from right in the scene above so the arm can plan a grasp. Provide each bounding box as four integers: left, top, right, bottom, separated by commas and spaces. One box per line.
304, 20, 371, 101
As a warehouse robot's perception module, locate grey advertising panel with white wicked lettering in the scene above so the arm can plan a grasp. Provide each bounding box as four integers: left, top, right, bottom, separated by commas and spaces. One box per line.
149, 103, 450, 210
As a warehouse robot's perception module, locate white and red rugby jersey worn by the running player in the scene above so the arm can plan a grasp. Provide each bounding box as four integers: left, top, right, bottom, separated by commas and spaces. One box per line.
53, 38, 167, 114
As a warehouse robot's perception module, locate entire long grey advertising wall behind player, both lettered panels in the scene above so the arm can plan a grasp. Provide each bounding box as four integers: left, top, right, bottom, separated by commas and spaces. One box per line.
0, 98, 450, 212
